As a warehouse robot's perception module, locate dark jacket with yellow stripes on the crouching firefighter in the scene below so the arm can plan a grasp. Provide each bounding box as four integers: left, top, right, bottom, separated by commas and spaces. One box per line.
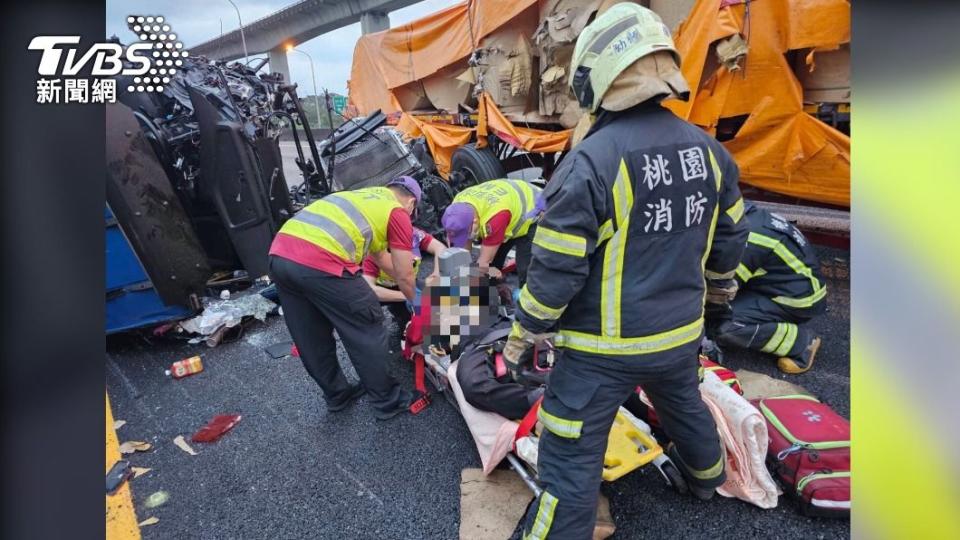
737, 203, 827, 311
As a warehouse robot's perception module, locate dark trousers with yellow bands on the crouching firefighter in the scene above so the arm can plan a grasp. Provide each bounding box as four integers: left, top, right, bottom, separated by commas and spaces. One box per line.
715, 290, 825, 367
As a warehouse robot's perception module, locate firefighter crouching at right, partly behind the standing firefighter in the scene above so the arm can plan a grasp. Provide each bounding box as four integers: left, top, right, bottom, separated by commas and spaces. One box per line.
708, 203, 827, 374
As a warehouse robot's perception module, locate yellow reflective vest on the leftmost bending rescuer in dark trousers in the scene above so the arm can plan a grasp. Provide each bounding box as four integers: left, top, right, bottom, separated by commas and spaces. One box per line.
280, 187, 401, 264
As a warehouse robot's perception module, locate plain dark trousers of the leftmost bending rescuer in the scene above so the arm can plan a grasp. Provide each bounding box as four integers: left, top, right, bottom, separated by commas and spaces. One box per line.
270, 256, 401, 410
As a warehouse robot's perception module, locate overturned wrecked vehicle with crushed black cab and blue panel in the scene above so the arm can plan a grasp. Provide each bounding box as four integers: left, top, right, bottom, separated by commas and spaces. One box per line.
106, 44, 453, 333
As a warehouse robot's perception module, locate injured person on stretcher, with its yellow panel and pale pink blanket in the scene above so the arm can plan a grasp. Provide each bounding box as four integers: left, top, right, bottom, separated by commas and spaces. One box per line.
404, 248, 779, 524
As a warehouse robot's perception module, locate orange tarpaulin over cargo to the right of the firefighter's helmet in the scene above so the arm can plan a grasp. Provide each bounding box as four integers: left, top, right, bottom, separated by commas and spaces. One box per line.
667, 0, 850, 206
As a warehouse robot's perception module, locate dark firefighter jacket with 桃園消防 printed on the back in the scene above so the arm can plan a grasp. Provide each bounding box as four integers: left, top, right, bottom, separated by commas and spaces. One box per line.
518, 102, 748, 355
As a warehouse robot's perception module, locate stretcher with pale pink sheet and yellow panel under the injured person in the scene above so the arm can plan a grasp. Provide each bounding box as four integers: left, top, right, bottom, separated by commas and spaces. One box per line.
412, 347, 687, 496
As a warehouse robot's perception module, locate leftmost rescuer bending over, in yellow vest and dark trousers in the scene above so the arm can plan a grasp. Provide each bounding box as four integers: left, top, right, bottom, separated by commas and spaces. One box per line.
270, 176, 421, 420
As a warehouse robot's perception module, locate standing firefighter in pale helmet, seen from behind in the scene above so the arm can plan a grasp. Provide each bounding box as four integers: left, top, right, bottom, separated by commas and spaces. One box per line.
504, 3, 748, 539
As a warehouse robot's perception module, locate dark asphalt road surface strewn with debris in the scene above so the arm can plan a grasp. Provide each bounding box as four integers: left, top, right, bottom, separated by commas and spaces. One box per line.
106, 247, 850, 540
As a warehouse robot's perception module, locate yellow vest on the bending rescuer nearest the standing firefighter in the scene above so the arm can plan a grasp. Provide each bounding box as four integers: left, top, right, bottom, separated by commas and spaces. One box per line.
453, 179, 540, 240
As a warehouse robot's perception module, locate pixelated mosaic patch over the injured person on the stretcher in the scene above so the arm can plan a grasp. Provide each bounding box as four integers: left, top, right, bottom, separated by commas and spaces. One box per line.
425, 266, 499, 352
